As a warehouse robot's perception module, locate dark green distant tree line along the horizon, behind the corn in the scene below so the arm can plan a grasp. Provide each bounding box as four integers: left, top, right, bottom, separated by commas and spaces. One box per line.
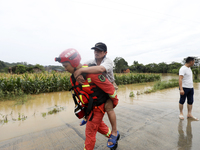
0, 57, 200, 74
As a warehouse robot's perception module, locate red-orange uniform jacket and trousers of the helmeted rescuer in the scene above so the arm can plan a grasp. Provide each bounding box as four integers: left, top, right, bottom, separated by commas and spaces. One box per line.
79, 74, 118, 150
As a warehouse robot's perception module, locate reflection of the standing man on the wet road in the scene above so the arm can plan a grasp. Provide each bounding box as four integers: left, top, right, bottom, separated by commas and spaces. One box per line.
178, 119, 193, 150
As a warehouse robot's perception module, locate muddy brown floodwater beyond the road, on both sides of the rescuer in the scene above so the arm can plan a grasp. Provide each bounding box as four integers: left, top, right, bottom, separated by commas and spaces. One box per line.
0, 75, 200, 141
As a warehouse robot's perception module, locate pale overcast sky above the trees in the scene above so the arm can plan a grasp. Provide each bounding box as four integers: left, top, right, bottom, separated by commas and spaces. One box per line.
0, 0, 200, 65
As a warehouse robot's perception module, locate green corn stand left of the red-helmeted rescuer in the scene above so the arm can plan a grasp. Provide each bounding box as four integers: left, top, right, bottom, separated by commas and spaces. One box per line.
0, 72, 71, 99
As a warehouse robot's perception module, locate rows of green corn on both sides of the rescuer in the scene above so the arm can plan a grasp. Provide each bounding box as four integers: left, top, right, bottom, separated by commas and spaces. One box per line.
0, 73, 160, 99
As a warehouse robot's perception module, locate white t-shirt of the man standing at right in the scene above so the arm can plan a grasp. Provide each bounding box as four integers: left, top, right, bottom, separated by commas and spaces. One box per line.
179, 65, 193, 88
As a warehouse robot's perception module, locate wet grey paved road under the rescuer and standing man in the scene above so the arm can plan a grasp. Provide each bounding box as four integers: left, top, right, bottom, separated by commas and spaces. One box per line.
0, 88, 200, 150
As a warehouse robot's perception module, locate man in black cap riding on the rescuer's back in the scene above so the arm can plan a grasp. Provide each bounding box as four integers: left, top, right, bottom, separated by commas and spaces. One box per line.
74, 42, 118, 146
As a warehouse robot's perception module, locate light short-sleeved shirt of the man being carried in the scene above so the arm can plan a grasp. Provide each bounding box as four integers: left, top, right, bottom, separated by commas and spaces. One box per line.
85, 57, 115, 83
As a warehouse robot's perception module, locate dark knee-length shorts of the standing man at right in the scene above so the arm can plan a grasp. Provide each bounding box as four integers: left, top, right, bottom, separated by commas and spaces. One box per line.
179, 88, 194, 105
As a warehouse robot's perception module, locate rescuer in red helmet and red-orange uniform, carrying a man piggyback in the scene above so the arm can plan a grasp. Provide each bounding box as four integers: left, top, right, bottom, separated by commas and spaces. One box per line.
55, 48, 120, 150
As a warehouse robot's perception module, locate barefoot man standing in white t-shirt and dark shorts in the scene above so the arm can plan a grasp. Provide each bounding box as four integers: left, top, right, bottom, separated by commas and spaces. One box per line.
179, 57, 199, 121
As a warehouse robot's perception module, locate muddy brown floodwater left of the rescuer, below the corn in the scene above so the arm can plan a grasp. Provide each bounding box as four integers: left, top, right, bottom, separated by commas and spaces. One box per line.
0, 92, 77, 141
